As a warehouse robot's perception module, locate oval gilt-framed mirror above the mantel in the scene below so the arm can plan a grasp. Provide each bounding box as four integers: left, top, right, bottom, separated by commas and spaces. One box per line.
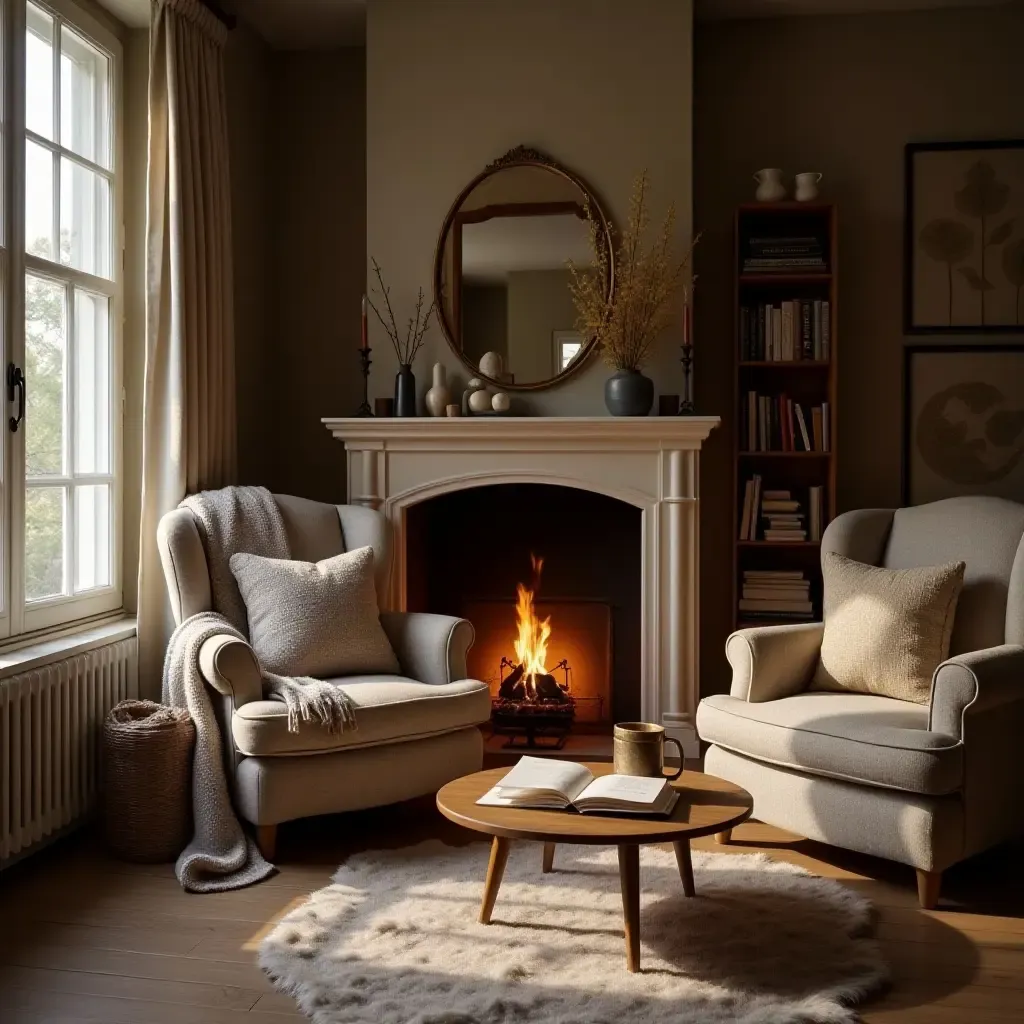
434, 146, 614, 391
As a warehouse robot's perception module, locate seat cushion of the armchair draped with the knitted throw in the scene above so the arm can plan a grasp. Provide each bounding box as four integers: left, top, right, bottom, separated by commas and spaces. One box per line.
231, 675, 490, 757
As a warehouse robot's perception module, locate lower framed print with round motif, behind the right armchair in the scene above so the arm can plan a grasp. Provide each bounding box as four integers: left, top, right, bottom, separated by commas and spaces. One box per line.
901, 341, 1024, 505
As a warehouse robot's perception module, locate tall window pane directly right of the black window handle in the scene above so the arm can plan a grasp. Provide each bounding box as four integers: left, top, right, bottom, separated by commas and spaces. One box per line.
25, 273, 68, 477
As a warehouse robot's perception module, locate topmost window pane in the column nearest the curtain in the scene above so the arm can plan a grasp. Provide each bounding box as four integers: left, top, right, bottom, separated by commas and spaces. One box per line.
60, 25, 112, 167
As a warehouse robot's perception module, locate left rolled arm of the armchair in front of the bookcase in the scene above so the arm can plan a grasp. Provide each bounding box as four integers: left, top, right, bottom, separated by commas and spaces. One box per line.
725, 623, 824, 703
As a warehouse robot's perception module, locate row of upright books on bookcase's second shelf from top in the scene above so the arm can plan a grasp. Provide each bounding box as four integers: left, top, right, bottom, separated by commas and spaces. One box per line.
739, 299, 831, 362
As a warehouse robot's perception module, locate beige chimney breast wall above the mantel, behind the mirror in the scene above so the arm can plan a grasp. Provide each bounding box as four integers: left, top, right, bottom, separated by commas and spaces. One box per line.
368, 0, 692, 415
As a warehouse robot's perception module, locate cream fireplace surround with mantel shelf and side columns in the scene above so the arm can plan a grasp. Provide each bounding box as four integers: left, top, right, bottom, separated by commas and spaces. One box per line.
324, 416, 719, 757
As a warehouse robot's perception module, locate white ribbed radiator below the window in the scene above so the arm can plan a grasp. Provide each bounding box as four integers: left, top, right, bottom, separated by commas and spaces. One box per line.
0, 637, 138, 868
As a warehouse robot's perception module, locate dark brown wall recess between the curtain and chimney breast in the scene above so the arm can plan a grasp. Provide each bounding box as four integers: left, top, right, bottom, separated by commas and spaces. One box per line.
227, 39, 366, 501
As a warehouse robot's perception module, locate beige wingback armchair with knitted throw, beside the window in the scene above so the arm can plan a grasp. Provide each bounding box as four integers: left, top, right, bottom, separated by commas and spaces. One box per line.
158, 495, 490, 858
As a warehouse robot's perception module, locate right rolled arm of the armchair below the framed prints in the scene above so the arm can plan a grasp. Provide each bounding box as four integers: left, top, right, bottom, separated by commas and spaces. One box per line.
928, 643, 1024, 739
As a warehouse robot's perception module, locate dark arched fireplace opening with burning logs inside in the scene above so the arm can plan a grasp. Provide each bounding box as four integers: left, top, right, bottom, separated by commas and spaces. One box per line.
406, 483, 642, 733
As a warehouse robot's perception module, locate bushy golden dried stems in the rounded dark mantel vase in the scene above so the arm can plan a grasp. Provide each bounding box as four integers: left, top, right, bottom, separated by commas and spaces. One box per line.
569, 171, 699, 371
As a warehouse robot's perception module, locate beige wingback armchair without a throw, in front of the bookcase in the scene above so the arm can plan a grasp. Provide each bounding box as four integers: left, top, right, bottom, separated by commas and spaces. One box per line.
696, 498, 1024, 908
